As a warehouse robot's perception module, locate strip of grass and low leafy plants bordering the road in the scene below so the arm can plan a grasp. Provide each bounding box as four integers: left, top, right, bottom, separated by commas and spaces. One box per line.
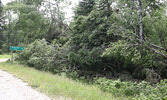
0, 62, 167, 100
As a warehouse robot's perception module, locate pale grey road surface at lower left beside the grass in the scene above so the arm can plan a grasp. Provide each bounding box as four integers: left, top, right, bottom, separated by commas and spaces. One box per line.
0, 59, 50, 100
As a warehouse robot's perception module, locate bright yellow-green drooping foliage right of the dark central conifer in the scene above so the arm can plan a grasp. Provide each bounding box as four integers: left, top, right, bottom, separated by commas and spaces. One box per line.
101, 41, 138, 72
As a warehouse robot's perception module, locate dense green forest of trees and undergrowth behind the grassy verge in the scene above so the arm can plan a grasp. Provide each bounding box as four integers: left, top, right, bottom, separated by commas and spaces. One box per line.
0, 0, 167, 100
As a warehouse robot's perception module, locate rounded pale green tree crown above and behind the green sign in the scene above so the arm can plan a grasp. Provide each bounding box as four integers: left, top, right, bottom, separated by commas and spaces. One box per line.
3, 2, 48, 46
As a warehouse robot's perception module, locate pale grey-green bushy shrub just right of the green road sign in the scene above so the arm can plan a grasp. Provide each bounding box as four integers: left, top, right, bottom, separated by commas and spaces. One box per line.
16, 40, 66, 73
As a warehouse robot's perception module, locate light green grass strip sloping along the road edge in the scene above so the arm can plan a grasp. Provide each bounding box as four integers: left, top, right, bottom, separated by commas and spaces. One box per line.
0, 62, 125, 100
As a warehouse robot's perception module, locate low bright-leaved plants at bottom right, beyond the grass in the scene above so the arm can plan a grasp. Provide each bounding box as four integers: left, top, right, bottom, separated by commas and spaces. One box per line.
95, 78, 167, 100
